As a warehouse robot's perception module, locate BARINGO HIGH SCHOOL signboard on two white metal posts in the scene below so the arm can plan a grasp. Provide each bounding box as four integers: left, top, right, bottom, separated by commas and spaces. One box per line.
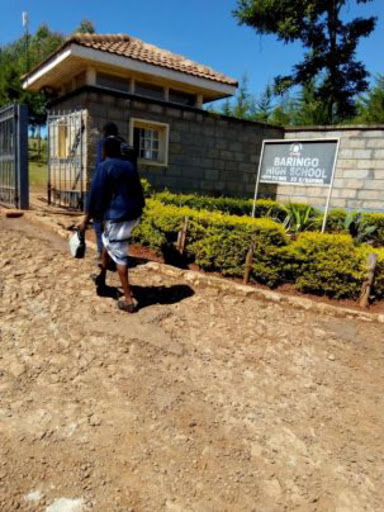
252, 138, 340, 233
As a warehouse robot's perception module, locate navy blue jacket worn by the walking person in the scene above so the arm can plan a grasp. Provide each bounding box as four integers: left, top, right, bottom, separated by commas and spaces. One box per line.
87, 158, 145, 222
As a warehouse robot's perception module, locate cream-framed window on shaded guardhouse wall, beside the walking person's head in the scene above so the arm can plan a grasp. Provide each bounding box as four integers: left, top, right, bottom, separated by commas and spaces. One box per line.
130, 119, 169, 165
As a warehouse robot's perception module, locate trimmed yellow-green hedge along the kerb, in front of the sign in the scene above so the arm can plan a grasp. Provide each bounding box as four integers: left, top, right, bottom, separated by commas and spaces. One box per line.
133, 199, 384, 299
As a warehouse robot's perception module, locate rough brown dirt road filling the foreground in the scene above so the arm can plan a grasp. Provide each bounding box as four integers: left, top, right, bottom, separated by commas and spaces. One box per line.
0, 220, 384, 512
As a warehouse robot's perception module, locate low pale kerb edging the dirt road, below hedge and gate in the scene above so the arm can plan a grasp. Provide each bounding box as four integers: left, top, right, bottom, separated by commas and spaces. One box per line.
5, 207, 384, 323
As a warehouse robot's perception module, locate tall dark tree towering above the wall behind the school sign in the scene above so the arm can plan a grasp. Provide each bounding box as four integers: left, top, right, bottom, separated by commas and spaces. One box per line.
234, 0, 376, 123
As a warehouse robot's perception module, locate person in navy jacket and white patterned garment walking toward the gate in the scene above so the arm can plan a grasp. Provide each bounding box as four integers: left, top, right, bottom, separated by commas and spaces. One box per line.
79, 136, 144, 313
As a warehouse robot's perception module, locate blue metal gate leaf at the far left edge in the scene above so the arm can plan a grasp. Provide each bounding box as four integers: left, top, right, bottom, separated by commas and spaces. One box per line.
0, 104, 29, 209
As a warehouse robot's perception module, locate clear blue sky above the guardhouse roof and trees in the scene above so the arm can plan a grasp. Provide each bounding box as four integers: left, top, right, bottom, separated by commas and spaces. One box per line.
0, 0, 384, 99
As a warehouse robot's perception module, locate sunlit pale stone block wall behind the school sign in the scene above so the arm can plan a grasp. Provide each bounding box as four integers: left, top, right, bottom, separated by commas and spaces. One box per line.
282, 126, 384, 211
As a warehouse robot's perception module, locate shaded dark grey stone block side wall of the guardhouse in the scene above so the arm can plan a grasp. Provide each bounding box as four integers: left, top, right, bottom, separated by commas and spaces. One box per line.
50, 87, 284, 197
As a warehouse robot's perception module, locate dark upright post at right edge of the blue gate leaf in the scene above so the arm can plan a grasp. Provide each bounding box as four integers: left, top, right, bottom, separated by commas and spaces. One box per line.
15, 104, 29, 210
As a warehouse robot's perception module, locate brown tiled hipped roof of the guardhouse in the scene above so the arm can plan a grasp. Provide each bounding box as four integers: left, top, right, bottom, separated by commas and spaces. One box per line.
70, 34, 237, 86
